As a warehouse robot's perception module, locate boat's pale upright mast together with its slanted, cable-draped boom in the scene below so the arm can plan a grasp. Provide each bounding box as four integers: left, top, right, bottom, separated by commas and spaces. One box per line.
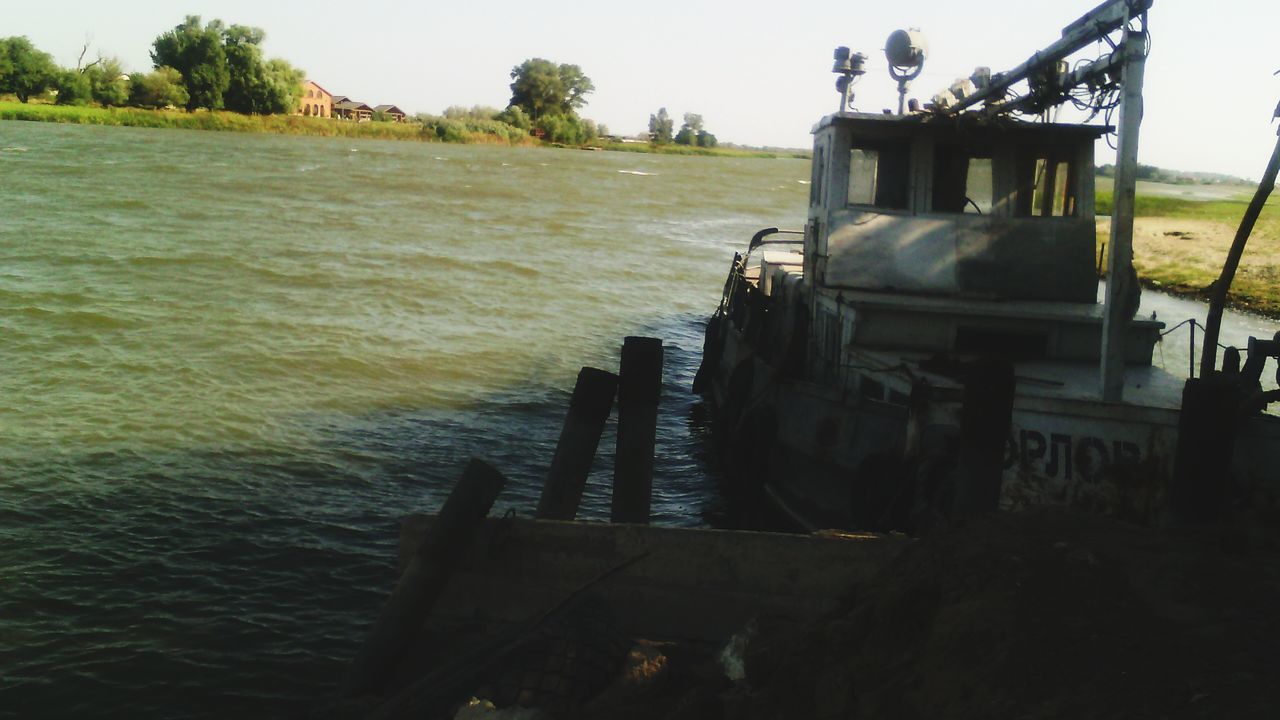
934, 0, 1152, 402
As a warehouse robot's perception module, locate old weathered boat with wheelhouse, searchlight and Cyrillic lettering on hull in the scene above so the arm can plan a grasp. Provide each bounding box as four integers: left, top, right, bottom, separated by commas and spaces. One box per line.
695, 0, 1280, 530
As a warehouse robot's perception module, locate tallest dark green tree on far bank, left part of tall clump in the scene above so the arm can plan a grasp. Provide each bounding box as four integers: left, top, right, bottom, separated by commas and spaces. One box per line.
151, 15, 230, 110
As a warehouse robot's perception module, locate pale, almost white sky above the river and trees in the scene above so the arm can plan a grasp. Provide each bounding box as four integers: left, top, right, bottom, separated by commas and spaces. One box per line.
0, 0, 1280, 178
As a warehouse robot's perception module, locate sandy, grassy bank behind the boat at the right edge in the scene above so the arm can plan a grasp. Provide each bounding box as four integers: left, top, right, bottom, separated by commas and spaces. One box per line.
1097, 186, 1280, 316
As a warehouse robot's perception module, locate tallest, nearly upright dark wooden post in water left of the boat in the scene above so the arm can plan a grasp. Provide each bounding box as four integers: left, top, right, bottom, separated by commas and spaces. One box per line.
612, 337, 662, 524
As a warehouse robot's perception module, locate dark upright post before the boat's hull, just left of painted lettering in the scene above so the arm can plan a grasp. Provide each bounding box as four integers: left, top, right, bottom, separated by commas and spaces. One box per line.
952, 359, 1015, 518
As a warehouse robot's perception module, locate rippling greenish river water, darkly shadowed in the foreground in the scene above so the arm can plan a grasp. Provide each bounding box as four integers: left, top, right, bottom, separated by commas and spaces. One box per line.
0, 122, 1275, 717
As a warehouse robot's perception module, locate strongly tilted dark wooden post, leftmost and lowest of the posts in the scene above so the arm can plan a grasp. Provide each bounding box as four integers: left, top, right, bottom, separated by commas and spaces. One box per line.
343, 457, 507, 697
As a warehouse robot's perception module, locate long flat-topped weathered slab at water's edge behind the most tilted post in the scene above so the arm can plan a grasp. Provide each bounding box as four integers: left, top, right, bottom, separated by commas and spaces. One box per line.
401, 515, 913, 643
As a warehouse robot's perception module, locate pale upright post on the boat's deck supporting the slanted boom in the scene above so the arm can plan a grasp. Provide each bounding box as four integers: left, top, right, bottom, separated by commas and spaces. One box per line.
1101, 31, 1147, 402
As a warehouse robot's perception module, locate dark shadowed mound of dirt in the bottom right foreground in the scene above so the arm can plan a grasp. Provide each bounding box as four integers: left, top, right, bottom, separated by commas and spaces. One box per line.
591, 509, 1280, 720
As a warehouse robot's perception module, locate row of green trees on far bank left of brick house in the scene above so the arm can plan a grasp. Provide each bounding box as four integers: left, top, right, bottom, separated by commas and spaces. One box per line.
0, 15, 305, 115
